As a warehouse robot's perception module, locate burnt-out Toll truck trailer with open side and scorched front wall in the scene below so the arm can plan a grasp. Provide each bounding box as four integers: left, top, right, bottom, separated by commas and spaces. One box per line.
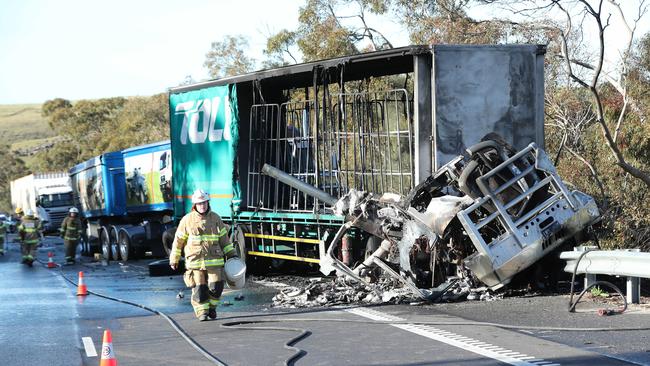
167, 45, 596, 292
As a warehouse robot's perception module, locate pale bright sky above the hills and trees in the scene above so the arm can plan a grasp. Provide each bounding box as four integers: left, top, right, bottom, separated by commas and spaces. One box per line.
0, 0, 650, 104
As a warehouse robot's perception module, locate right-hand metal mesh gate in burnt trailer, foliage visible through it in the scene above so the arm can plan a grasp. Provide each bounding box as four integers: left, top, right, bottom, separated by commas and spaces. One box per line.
326, 90, 414, 196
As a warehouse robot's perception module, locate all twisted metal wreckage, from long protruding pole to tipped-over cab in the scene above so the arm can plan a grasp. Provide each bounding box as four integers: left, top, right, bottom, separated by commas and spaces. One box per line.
262, 134, 599, 304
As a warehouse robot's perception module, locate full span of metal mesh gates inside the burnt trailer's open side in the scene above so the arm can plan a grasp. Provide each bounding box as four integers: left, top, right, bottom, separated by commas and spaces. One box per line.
248, 90, 414, 212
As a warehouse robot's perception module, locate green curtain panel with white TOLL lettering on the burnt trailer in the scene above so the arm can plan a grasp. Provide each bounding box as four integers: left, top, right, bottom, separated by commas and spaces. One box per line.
169, 85, 240, 217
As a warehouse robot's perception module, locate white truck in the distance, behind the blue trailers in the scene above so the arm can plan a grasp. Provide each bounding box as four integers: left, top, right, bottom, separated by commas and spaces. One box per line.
11, 172, 73, 232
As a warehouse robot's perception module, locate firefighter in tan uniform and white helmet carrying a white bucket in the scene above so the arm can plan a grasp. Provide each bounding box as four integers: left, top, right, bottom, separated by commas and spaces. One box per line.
169, 189, 237, 321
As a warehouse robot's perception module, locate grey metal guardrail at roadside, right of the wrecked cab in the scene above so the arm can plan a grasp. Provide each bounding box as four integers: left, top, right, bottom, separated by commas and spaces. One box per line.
560, 248, 650, 304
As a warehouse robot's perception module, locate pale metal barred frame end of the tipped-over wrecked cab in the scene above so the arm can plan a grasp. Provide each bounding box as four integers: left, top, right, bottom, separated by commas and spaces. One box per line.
448, 143, 600, 290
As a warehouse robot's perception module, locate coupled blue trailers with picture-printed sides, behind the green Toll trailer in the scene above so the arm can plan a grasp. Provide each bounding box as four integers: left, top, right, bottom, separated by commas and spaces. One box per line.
70, 141, 172, 261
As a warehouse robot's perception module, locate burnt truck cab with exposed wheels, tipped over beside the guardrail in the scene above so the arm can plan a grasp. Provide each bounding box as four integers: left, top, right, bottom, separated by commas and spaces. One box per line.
360, 134, 599, 290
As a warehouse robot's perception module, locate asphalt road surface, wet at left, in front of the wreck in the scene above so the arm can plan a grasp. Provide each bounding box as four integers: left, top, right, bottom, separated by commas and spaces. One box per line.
0, 233, 650, 366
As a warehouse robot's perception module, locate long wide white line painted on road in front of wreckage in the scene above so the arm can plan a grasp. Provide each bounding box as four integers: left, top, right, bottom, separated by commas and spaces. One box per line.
346, 308, 559, 366
